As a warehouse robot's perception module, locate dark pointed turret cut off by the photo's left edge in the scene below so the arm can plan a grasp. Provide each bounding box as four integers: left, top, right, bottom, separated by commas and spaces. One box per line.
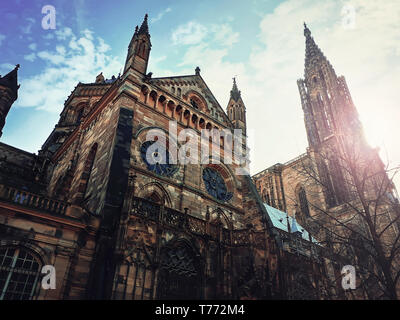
0, 64, 19, 137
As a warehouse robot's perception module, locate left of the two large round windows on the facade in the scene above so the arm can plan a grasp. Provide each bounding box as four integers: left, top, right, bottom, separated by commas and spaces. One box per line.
140, 141, 178, 177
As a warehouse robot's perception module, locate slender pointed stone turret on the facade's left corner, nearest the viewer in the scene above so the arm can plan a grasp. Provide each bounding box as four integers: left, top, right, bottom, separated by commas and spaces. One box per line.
124, 14, 151, 74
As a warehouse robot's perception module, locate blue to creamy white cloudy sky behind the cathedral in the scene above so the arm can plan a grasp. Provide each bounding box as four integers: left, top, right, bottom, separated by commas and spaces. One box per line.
0, 0, 400, 187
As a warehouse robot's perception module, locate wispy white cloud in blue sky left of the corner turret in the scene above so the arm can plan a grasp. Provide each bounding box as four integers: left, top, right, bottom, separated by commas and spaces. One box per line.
15, 28, 123, 112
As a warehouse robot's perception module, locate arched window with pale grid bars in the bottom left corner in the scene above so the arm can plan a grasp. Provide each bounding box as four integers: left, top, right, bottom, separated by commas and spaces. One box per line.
0, 247, 42, 300
